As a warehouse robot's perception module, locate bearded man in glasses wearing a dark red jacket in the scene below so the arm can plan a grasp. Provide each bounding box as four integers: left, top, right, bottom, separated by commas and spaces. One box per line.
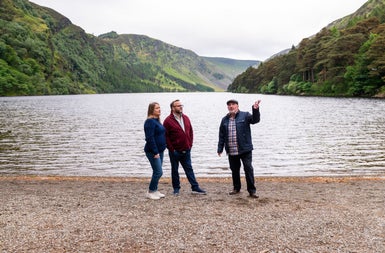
163, 100, 206, 195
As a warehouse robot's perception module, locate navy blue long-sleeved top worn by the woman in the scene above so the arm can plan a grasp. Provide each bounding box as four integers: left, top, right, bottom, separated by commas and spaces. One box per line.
144, 118, 166, 155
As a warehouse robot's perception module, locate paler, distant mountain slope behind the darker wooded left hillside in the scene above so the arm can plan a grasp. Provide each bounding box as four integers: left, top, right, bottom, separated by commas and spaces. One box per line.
99, 32, 254, 90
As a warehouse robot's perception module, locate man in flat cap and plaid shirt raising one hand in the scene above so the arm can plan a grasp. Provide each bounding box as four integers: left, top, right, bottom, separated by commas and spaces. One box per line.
217, 99, 260, 198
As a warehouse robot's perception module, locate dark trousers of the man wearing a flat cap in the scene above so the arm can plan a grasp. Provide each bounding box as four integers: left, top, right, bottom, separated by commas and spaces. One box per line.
229, 151, 257, 193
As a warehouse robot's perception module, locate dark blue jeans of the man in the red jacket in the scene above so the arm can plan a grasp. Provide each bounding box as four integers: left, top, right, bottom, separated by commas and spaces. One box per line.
168, 150, 199, 190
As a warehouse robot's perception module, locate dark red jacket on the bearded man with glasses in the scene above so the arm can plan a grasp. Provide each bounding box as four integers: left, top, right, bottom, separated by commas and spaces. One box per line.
163, 112, 194, 152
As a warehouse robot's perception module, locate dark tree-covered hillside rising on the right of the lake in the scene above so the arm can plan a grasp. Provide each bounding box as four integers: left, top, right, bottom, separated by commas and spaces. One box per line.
228, 0, 385, 97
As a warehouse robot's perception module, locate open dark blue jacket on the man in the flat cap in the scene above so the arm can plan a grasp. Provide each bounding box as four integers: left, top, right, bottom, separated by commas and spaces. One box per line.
217, 107, 261, 154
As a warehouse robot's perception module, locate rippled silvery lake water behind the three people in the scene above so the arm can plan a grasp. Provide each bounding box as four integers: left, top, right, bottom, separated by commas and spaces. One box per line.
0, 93, 385, 177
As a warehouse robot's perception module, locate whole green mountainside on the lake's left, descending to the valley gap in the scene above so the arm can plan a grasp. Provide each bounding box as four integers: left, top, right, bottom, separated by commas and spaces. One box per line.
0, 0, 255, 96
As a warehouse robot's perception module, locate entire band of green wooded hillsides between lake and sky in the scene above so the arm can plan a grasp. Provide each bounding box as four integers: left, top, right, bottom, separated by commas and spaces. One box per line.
0, 0, 385, 97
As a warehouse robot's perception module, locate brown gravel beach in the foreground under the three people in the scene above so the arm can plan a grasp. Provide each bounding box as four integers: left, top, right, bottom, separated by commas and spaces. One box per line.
0, 176, 385, 253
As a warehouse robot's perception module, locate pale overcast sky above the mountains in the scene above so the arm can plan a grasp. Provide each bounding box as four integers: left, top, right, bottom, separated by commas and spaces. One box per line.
31, 0, 367, 60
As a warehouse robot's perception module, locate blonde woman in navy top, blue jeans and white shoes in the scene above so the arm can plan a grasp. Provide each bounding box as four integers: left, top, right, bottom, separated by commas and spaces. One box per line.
144, 102, 166, 199
